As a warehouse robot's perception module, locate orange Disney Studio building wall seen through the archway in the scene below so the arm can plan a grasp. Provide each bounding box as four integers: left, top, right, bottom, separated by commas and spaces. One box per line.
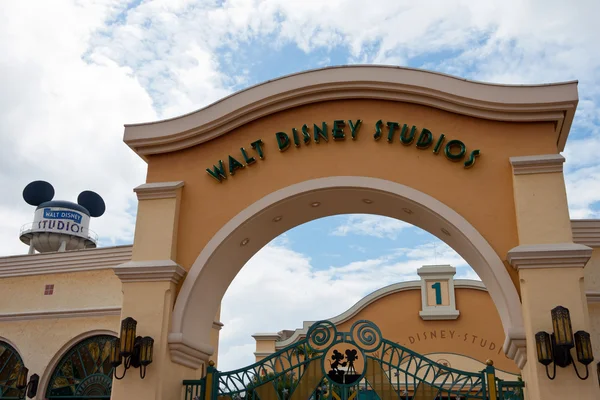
264, 288, 520, 374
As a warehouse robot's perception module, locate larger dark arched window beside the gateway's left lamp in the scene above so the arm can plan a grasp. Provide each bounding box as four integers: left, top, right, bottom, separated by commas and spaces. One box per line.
46, 335, 116, 400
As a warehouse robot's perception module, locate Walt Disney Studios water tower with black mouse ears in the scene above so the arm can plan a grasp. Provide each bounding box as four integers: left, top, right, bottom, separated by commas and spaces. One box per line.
21, 181, 106, 254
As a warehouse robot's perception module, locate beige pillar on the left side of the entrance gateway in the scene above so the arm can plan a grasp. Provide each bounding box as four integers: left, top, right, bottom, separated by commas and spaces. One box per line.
111, 182, 201, 400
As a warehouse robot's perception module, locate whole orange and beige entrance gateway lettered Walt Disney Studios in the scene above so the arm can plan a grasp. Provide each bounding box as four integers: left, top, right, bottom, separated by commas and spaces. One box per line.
114, 65, 598, 399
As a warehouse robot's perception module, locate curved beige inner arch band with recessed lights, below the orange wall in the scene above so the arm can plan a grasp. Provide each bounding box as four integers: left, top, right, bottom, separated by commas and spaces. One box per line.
169, 176, 526, 368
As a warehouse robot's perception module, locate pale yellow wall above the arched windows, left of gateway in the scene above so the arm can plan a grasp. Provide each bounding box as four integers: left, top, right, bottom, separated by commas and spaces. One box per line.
0, 268, 123, 398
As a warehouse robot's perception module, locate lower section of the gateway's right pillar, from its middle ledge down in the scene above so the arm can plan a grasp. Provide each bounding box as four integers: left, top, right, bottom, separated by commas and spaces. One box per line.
507, 243, 600, 400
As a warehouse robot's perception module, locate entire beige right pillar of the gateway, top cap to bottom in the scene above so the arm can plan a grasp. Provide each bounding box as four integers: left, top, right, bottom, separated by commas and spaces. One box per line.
507, 154, 600, 400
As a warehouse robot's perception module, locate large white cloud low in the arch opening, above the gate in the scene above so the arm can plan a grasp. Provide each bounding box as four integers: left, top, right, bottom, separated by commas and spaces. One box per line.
219, 238, 477, 370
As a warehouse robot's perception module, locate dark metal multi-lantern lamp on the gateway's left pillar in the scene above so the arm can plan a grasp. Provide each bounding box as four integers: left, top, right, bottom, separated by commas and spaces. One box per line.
110, 317, 154, 379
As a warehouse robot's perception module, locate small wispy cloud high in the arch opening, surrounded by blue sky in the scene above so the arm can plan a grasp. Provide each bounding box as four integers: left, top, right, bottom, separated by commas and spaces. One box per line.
331, 214, 412, 239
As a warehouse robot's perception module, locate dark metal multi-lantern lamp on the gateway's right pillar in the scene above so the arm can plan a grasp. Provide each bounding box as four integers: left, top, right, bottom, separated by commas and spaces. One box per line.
535, 306, 594, 380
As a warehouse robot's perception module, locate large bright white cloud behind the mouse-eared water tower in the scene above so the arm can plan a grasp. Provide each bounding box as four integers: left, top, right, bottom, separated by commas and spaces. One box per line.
0, 1, 156, 254
